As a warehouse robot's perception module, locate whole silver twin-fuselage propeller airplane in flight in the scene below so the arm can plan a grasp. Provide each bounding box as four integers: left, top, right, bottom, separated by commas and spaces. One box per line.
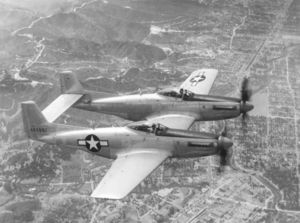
22, 69, 253, 199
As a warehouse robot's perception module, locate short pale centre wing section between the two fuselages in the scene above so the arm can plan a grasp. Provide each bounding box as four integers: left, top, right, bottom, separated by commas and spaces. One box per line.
147, 114, 196, 130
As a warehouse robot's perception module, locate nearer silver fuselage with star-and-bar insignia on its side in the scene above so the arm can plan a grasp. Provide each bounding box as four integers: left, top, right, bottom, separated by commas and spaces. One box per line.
37, 127, 224, 159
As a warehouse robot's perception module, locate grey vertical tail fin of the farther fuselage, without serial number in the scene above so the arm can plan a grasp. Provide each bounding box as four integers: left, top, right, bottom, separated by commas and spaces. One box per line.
60, 71, 85, 94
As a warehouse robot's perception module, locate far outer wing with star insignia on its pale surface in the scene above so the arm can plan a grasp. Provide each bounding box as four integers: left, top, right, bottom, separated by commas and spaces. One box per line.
180, 69, 218, 95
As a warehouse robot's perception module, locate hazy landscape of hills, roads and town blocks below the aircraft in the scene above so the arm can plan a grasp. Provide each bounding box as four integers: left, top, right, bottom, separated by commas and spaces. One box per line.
0, 0, 300, 223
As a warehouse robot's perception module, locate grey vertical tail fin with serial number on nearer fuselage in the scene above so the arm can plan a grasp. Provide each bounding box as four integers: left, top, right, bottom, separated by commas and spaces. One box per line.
21, 101, 51, 139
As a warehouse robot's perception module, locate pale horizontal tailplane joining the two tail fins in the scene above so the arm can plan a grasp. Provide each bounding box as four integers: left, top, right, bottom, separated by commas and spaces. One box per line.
42, 94, 83, 122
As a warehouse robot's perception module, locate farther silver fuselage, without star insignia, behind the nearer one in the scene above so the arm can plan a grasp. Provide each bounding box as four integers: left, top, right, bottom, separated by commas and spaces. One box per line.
74, 93, 241, 121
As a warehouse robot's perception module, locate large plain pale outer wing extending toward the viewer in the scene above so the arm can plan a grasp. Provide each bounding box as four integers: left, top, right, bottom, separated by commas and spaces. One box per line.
91, 150, 169, 199
